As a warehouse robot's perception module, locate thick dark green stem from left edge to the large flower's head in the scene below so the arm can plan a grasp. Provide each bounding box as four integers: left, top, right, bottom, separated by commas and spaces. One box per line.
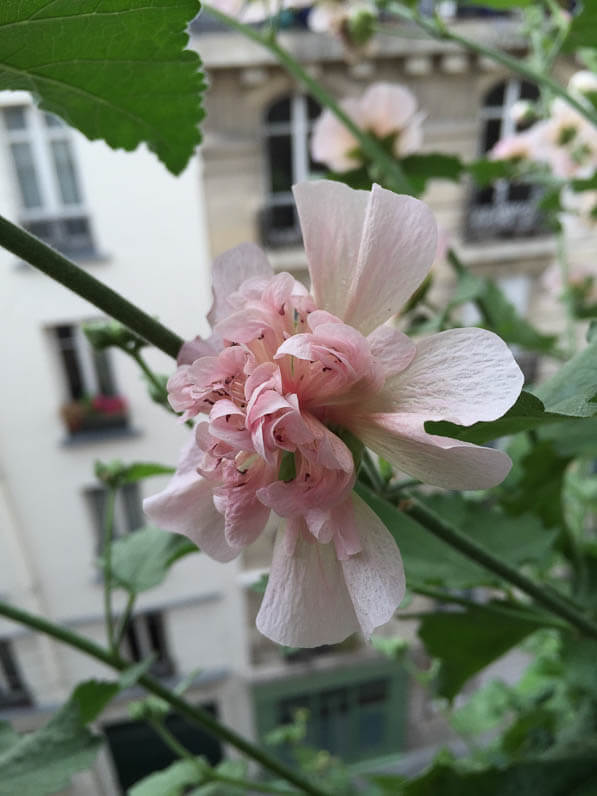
0, 216, 183, 358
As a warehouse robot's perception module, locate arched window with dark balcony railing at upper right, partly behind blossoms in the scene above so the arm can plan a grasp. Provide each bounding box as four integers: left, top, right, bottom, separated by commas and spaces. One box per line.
466, 79, 545, 240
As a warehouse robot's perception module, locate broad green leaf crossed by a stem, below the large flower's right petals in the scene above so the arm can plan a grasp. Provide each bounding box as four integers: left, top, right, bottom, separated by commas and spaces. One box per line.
355, 483, 556, 590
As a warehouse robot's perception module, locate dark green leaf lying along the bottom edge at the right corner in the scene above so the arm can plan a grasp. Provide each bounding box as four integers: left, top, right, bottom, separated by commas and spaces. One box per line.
395, 756, 597, 796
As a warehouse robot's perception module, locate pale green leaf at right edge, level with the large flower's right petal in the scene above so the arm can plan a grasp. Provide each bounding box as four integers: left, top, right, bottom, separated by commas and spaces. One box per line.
535, 340, 597, 417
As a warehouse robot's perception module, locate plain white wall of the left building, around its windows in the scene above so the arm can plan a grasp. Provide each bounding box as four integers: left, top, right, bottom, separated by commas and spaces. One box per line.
0, 93, 246, 702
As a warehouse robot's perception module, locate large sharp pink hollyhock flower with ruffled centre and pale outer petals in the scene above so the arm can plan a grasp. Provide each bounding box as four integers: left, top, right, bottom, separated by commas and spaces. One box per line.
144, 181, 522, 647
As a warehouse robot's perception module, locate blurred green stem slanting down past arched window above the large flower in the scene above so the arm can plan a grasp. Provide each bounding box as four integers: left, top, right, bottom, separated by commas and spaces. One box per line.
203, 3, 412, 194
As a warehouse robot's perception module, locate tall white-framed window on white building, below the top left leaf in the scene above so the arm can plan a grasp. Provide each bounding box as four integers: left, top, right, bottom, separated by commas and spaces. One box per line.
2, 105, 94, 256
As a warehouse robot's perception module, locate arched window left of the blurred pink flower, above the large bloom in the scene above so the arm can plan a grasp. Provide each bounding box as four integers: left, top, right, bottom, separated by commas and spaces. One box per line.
261, 94, 325, 247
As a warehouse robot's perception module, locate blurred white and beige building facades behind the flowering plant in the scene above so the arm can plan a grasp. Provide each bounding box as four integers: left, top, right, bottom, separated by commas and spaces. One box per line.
0, 3, 582, 796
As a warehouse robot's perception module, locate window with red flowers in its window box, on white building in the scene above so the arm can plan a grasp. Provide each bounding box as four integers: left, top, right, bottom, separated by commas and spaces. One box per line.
52, 324, 128, 435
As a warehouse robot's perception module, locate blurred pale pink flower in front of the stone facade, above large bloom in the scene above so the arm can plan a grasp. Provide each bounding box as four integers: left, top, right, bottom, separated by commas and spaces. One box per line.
311, 83, 423, 172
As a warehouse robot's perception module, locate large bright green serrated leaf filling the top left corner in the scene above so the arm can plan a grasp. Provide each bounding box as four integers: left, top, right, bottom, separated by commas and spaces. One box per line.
0, 0, 205, 174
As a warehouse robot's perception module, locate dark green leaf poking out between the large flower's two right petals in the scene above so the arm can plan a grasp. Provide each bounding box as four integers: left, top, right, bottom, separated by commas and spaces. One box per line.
425, 390, 567, 445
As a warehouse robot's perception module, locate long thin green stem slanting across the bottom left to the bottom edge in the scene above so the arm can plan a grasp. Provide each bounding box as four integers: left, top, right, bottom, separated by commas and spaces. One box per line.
0, 601, 329, 796
